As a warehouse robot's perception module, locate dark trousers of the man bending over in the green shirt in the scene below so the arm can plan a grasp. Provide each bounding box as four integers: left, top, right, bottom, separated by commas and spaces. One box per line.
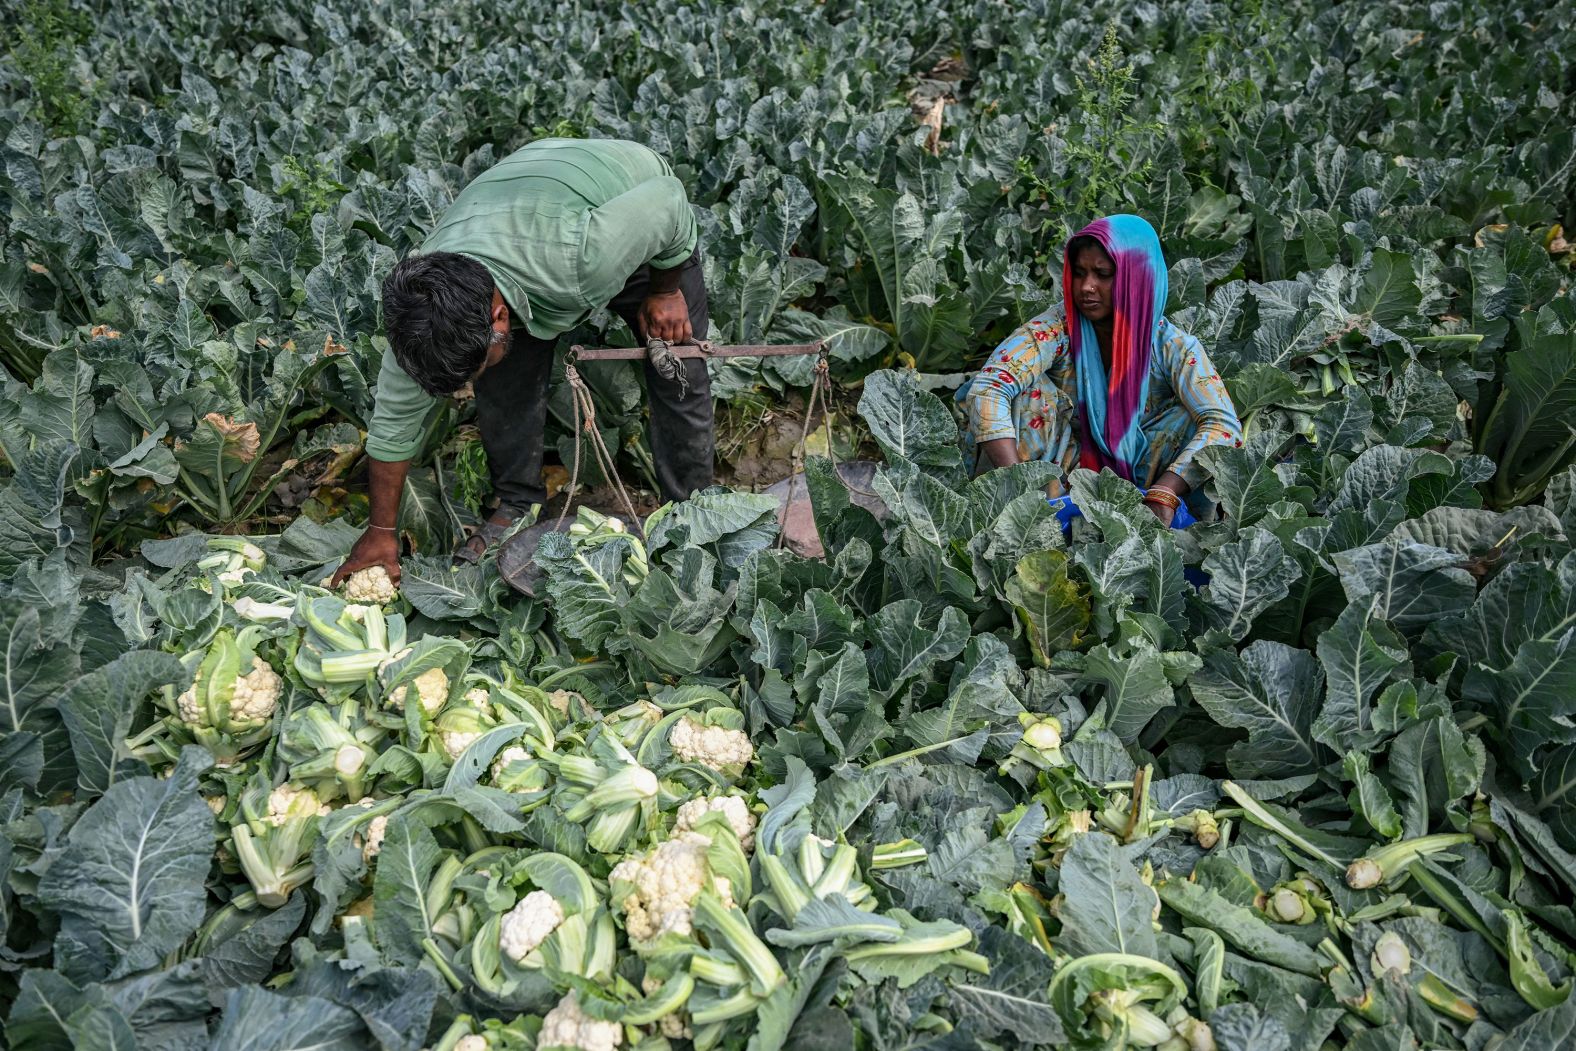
476, 249, 716, 514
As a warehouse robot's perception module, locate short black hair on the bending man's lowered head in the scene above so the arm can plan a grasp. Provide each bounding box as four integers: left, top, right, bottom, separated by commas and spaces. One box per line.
383, 252, 493, 397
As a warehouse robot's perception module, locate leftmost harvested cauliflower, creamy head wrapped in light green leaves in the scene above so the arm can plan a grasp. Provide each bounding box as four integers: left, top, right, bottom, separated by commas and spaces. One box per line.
165, 627, 284, 766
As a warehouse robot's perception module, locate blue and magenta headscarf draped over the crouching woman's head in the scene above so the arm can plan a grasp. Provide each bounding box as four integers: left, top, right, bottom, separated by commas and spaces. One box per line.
1062, 216, 1168, 481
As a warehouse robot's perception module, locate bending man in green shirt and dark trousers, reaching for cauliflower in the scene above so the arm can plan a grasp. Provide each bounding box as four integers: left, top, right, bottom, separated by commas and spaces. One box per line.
337, 139, 714, 578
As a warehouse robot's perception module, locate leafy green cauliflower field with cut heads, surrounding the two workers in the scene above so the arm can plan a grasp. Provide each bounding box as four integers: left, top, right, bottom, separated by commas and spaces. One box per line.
0, 0, 1576, 1051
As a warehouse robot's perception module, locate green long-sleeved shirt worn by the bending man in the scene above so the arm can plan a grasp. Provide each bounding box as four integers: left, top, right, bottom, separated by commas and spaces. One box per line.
367, 139, 698, 460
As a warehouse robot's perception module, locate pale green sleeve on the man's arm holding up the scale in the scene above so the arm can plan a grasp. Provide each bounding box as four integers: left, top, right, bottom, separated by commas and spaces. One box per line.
580, 175, 700, 310
